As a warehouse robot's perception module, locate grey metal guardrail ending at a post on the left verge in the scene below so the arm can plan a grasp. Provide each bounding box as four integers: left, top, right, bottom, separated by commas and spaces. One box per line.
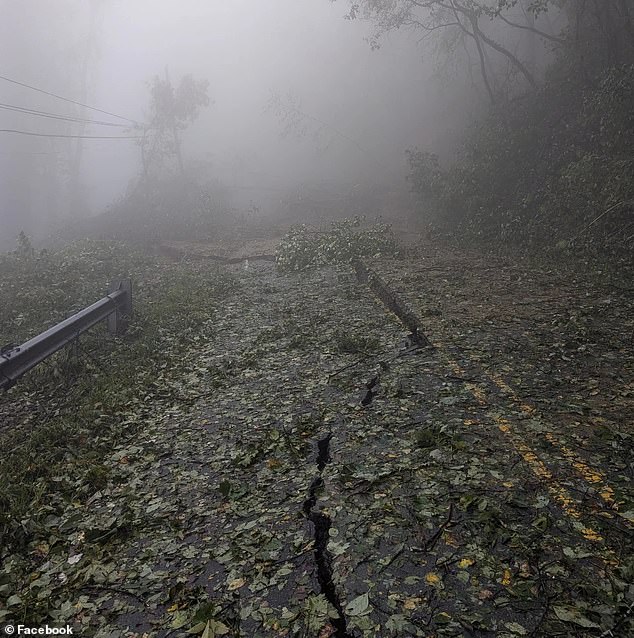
0, 279, 132, 390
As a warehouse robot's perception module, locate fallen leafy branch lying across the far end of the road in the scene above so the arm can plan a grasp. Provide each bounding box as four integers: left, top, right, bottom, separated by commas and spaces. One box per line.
276, 216, 398, 272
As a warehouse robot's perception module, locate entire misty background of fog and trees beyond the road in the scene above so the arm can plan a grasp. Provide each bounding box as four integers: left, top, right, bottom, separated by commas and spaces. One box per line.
0, 0, 634, 253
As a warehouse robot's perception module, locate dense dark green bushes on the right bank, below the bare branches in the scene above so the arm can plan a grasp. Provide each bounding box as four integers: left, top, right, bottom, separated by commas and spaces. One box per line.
409, 66, 634, 251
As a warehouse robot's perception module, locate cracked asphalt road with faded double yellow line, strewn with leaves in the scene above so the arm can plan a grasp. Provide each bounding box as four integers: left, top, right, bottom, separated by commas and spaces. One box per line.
16, 246, 634, 637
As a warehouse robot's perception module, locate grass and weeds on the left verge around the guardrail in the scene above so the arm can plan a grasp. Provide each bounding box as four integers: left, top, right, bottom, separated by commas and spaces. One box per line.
0, 236, 236, 592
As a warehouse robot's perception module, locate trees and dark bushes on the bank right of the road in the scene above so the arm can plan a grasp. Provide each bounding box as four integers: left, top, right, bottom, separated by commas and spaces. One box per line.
336, 0, 634, 260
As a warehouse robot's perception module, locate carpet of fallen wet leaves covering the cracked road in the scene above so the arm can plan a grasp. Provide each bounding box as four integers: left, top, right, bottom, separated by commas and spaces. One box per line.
0, 242, 632, 637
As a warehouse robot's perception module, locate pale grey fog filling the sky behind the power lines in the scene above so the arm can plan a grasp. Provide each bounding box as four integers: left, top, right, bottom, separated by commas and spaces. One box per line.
0, 0, 478, 249
